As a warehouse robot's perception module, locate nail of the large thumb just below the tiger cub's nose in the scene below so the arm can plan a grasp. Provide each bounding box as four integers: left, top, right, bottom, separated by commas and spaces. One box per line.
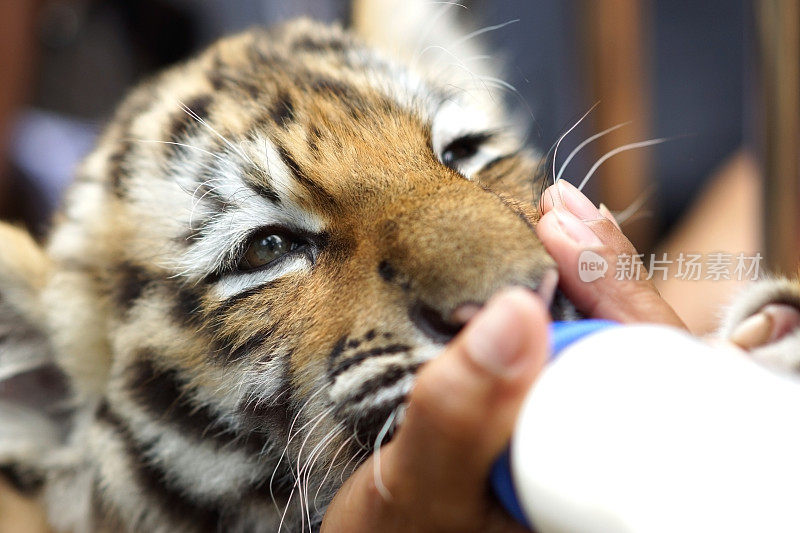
465, 289, 530, 377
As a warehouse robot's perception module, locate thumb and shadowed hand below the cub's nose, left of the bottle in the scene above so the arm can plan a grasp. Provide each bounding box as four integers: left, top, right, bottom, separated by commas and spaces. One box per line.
326, 288, 548, 531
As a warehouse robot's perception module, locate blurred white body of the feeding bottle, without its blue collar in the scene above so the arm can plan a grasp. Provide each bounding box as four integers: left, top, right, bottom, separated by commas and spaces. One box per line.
511, 326, 800, 533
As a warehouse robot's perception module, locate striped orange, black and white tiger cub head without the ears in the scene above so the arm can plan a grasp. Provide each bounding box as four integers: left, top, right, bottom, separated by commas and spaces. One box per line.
32, 15, 554, 531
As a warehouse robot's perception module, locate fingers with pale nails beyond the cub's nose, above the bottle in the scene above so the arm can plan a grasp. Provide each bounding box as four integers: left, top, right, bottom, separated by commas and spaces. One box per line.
536, 180, 685, 328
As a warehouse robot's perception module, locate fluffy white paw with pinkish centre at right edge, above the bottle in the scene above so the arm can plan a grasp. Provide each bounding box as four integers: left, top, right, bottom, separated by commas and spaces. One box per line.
720, 279, 800, 372
